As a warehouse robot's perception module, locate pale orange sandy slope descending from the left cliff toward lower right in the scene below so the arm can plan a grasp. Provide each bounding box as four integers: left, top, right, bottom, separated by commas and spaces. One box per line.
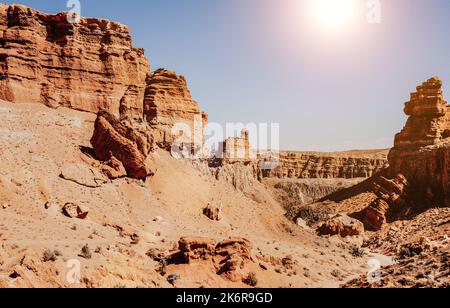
0, 102, 366, 287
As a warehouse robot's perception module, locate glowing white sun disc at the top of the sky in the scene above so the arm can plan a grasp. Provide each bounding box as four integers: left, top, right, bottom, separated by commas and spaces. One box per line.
310, 0, 355, 31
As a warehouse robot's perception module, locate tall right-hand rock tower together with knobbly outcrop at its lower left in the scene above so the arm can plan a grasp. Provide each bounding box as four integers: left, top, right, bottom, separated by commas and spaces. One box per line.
364, 77, 450, 230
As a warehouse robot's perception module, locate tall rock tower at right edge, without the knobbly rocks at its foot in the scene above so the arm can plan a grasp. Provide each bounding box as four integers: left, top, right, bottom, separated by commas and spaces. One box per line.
389, 77, 450, 205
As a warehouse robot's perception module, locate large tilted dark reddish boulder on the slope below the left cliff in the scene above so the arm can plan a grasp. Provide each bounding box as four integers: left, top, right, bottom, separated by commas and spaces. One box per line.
91, 111, 154, 179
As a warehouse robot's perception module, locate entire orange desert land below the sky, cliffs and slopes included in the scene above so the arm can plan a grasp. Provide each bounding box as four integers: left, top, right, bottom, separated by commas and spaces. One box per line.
0, 4, 450, 288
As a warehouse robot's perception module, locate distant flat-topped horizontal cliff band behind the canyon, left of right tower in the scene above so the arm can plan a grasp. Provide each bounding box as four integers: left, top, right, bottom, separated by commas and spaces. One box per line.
263, 151, 387, 179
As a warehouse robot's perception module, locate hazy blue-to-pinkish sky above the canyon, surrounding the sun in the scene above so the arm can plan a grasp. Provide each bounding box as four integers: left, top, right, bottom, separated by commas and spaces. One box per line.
2, 0, 450, 150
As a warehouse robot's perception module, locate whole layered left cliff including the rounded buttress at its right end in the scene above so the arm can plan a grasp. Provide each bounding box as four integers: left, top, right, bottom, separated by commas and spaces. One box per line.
0, 4, 207, 155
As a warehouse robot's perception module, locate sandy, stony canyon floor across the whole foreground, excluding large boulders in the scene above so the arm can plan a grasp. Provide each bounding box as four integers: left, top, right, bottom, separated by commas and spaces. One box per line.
0, 101, 450, 288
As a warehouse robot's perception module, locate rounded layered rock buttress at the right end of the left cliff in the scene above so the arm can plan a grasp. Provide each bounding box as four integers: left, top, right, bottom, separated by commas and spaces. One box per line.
144, 69, 208, 150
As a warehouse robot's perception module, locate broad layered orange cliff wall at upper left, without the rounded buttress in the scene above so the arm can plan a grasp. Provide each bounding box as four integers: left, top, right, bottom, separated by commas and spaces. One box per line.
0, 4, 149, 118
